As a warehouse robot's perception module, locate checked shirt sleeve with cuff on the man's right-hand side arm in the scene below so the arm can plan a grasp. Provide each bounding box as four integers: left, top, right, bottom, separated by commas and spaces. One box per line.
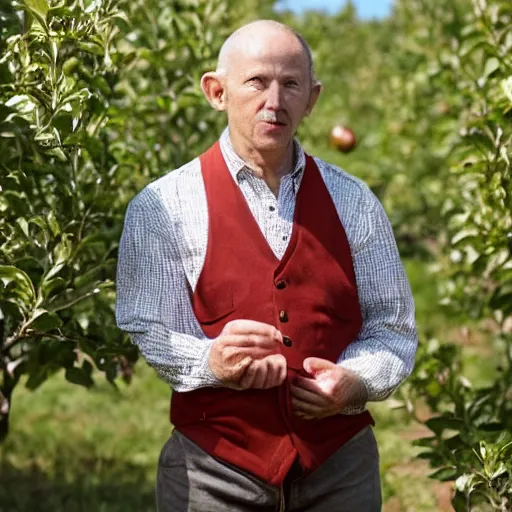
338, 190, 418, 414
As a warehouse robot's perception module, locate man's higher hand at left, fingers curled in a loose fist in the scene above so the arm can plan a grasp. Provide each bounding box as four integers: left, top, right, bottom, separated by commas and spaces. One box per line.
208, 320, 286, 389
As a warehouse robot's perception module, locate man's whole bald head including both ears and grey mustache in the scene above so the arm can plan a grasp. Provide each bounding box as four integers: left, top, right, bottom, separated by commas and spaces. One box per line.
201, 21, 322, 158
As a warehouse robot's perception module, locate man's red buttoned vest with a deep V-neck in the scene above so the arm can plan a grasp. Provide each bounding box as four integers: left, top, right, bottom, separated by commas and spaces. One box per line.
171, 143, 373, 485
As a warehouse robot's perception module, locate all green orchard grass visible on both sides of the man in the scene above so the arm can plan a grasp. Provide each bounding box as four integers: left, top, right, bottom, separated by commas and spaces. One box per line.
0, 261, 496, 512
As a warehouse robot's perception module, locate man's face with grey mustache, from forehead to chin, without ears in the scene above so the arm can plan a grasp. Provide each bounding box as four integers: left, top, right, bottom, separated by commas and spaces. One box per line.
224, 30, 312, 152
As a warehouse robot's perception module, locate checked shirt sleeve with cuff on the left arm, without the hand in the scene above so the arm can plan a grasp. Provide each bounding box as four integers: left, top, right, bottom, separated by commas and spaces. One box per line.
116, 188, 219, 391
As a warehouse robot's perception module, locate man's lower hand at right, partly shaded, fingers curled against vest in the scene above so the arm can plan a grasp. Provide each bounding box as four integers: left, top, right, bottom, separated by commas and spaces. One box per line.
291, 357, 367, 420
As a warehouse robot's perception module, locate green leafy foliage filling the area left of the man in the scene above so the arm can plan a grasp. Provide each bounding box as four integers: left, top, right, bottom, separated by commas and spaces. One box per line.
0, 0, 227, 440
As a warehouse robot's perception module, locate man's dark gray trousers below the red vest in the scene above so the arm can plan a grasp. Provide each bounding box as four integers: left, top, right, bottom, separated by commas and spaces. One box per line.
156, 427, 382, 512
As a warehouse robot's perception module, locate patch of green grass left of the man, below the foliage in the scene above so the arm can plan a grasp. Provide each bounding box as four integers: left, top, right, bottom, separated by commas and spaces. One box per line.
0, 364, 171, 512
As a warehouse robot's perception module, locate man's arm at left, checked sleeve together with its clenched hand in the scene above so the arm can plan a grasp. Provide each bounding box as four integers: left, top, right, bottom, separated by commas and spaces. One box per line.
116, 189, 286, 391
